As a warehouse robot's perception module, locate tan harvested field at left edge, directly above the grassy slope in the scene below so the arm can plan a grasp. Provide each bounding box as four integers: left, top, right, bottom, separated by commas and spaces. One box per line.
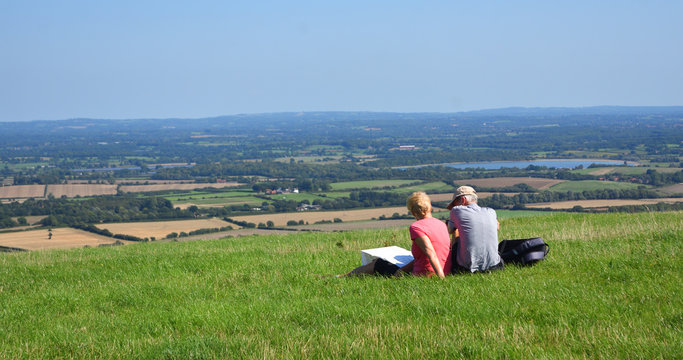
0, 228, 131, 250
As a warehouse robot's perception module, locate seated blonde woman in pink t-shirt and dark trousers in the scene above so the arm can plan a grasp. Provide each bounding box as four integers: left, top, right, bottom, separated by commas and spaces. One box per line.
346, 192, 451, 278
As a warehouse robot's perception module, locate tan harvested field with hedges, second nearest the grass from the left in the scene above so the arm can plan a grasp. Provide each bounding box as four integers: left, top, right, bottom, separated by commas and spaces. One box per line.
96, 218, 239, 239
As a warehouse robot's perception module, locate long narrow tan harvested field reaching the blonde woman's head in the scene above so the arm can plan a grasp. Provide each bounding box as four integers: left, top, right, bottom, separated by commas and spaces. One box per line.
233, 206, 408, 226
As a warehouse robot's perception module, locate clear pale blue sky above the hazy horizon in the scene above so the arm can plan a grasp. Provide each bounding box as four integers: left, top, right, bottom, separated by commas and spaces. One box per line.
0, 0, 683, 121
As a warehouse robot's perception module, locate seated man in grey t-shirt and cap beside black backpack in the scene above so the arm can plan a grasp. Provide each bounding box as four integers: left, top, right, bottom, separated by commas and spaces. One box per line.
447, 186, 503, 273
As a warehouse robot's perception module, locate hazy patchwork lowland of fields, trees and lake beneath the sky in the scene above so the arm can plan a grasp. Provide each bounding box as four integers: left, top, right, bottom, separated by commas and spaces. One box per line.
0, 107, 683, 249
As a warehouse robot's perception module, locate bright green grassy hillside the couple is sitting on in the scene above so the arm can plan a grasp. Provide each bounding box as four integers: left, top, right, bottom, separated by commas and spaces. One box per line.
0, 212, 683, 359
